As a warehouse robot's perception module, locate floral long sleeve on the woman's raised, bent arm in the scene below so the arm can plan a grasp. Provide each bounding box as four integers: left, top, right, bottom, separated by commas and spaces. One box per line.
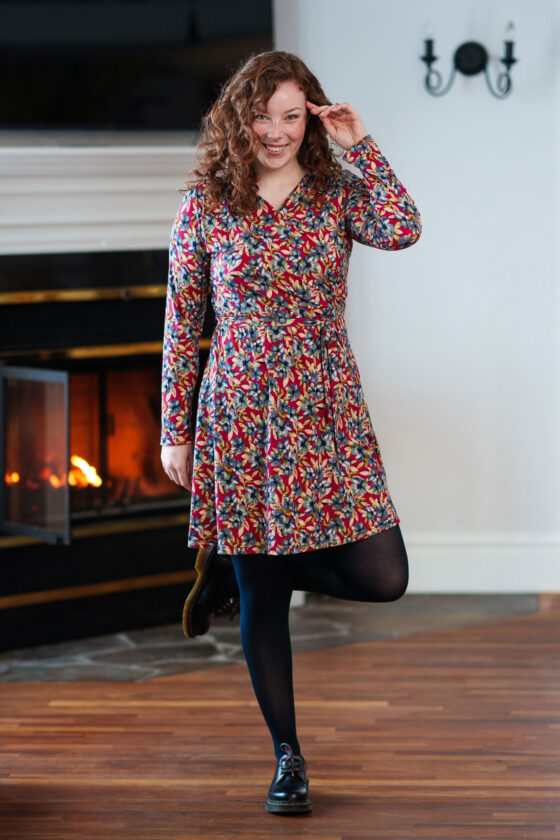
343, 134, 422, 251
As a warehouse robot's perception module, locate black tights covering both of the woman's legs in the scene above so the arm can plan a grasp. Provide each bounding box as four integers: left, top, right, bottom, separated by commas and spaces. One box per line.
232, 525, 408, 758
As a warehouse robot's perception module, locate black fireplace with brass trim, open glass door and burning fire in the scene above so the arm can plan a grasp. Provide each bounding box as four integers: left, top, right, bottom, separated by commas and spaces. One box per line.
0, 241, 215, 649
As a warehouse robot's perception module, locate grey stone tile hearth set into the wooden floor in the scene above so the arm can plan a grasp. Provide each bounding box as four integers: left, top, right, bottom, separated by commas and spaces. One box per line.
0, 594, 539, 682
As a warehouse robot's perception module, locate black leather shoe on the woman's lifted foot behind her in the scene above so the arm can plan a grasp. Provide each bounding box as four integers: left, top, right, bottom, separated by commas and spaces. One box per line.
183, 543, 239, 639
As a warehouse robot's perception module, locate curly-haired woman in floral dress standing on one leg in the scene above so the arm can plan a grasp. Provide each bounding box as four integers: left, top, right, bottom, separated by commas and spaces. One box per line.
161, 51, 421, 813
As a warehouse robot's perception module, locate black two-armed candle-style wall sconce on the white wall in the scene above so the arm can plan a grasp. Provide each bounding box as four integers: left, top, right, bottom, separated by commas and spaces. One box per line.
420, 23, 518, 99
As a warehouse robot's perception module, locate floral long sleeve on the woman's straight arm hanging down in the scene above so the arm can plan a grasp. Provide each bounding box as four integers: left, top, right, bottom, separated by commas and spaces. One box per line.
160, 188, 210, 445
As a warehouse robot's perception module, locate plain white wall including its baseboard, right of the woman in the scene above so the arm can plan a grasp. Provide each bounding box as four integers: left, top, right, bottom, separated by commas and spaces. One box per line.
275, 0, 560, 592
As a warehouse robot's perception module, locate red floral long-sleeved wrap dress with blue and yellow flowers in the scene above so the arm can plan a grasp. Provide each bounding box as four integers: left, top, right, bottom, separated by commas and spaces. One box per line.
161, 134, 422, 554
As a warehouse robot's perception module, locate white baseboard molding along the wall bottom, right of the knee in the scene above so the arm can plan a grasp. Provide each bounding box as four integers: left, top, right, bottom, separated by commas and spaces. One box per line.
403, 532, 560, 593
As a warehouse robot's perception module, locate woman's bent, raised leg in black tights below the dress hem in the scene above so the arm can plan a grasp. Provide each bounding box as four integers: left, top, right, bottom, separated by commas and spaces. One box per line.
291, 524, 408, 601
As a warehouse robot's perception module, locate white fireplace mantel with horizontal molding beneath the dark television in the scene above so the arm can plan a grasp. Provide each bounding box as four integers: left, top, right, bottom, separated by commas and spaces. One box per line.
0, 131, 195, 254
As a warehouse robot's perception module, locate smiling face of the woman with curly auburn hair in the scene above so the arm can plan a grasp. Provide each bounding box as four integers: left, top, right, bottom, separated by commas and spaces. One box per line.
251, 81, 307, 175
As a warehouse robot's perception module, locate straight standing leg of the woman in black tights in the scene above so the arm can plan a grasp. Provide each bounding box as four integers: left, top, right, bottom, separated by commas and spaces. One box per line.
232, 554, 300, 759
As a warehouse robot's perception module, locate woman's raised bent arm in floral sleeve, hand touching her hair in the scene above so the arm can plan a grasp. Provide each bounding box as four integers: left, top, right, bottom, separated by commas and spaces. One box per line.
306, 100, 422, 251
